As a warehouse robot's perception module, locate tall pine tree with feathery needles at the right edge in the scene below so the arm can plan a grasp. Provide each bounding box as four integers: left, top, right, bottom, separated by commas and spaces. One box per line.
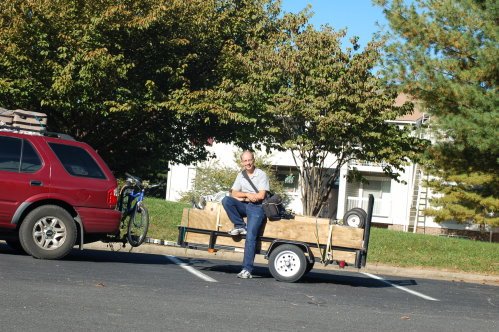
375, 0, 499, 225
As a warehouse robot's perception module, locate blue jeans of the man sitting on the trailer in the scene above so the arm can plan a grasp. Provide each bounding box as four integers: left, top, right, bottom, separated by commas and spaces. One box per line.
222, 196, 265, 273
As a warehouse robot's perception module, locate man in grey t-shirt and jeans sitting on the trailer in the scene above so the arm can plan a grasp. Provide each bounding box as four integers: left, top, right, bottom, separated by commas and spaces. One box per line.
222, 151, 270, 279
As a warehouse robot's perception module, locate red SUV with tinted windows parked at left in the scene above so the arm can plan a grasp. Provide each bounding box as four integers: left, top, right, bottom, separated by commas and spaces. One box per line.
0, 131, 120, 259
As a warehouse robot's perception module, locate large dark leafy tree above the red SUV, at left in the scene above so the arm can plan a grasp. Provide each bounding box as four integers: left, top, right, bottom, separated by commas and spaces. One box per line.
0, 0, 277, 176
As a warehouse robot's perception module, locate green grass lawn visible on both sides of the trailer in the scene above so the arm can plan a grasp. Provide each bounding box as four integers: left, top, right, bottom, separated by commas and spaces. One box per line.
146, 198, 499, 275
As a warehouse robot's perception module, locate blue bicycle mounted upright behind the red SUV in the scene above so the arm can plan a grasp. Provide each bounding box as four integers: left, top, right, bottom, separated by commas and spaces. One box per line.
117, 173, 159, 247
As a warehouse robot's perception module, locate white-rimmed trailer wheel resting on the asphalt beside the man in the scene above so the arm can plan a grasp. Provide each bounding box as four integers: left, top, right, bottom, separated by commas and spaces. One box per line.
269, 244, 307, 282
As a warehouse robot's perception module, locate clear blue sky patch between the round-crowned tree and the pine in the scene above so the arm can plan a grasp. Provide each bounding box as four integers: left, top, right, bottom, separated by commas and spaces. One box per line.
282, 0, 387, 46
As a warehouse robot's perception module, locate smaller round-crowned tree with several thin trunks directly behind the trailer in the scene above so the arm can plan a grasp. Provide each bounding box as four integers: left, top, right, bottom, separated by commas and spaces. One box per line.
193, 11, 428, 215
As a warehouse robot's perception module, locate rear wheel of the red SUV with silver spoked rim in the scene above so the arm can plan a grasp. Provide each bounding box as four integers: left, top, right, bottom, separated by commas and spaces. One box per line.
19, 205, 77, 259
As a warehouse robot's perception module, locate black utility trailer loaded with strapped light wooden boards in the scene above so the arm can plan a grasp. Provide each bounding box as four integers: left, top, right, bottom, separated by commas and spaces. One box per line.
177, 195, 374, 282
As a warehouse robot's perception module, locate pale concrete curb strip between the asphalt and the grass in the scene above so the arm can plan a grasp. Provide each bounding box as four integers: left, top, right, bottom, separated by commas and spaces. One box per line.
84, 242, 499, 286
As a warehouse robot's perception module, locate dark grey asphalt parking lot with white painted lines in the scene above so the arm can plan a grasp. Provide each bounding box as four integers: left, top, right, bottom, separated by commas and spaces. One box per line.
0, 243, 499, 332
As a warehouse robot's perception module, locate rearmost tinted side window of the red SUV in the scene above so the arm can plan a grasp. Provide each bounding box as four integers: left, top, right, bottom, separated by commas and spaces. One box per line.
49, 143, 106, 179
